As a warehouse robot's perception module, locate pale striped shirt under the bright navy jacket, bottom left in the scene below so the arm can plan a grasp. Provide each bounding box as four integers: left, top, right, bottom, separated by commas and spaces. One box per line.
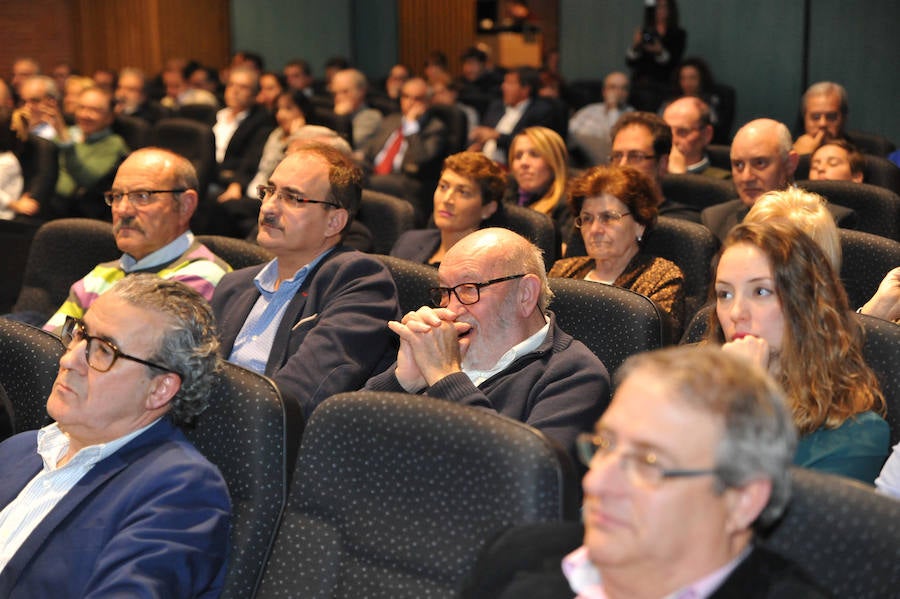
0, 418, 159, 571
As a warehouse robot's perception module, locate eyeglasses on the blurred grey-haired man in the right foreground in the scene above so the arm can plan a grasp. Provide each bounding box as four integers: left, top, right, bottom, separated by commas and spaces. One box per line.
575, 433, 718, 487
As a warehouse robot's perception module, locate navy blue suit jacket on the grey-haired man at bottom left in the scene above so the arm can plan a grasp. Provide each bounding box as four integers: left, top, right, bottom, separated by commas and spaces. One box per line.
0, 417, 231, 599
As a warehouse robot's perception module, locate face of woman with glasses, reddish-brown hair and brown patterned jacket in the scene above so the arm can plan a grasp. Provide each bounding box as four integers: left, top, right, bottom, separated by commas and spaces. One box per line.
580, 193, 644, 262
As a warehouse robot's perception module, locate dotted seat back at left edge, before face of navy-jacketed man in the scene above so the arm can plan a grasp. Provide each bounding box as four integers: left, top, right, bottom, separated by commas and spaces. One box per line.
0, 318, 65, 440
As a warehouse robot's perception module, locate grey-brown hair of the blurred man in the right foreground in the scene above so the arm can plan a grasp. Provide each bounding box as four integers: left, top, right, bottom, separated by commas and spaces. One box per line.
616, 345, 797, 526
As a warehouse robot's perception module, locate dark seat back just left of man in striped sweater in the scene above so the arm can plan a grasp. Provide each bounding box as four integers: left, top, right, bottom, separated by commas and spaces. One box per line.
7, 218, 122, 322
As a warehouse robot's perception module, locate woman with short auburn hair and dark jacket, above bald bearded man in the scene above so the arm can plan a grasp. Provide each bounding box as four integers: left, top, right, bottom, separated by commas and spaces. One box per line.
391, 152, 506, 266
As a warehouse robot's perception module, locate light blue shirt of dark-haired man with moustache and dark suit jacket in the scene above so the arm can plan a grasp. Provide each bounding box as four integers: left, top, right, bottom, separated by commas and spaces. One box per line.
228, 249, 332, 374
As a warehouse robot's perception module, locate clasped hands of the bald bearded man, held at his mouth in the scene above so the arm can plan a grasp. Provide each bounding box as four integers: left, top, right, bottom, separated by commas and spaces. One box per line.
388, 306, 472, 393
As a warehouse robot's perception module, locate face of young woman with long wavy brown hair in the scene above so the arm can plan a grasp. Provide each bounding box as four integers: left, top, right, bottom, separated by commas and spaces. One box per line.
716, 243, 784, 353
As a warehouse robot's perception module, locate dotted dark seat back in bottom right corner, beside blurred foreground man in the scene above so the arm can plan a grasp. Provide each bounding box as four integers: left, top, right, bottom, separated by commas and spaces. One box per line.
764, 468, 900, 599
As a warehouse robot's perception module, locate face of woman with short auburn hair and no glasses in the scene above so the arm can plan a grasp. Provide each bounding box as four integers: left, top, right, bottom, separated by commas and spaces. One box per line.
434, 169, 497, 232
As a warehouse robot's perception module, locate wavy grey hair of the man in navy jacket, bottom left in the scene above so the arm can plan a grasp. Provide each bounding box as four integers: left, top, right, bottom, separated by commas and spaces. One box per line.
108, 274, 219, 425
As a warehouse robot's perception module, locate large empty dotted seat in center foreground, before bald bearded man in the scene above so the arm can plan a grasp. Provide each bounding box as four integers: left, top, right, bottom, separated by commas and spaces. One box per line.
257, 391, 577, 599
